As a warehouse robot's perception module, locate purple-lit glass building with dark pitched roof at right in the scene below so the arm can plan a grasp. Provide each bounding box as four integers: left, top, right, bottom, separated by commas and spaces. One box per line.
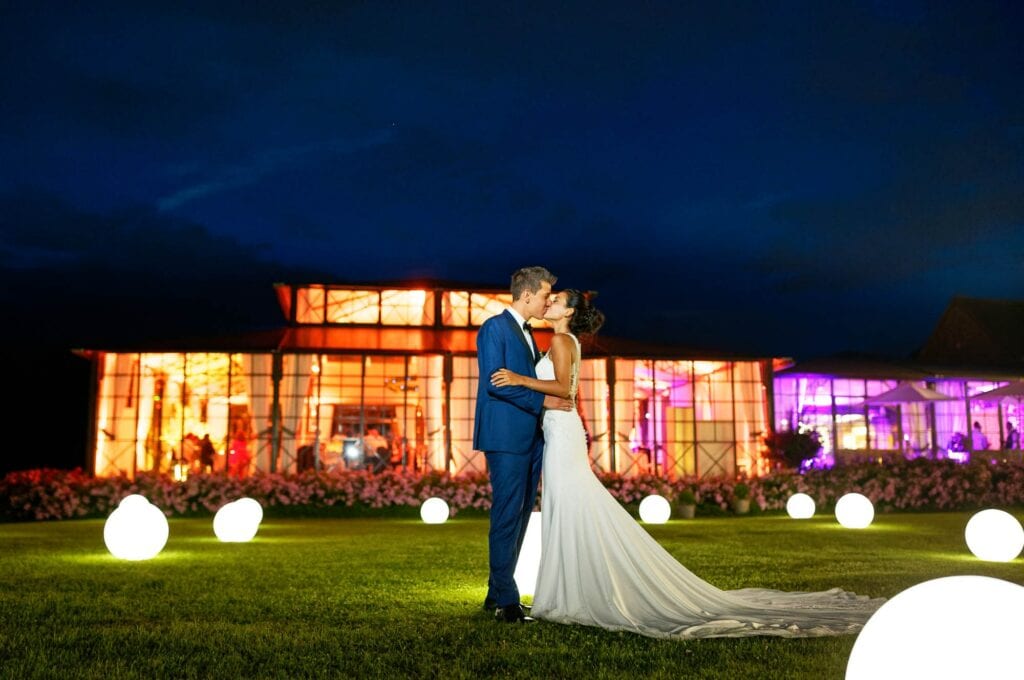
773, 297, 1024, 465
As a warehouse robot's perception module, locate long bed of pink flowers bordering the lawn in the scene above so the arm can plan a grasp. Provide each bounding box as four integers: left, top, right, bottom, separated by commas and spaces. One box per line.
0, 460, 1024, 521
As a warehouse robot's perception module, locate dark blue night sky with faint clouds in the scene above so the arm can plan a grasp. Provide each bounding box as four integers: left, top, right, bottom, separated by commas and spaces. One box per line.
0, 1, 1024, 356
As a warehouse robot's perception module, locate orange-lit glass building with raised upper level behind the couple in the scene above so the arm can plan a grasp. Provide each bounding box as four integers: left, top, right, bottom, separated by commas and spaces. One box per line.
82, 284, 772, 478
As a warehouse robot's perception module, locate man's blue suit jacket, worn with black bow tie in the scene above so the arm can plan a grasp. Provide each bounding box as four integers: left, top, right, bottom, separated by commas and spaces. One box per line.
473, 309, 544, 454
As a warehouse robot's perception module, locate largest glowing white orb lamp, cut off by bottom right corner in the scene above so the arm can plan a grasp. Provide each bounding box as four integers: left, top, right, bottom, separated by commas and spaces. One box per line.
846, 576, 1024, 680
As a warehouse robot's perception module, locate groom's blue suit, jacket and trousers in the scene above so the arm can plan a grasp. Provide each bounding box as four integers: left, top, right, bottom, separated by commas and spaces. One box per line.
473, 310, 544, 607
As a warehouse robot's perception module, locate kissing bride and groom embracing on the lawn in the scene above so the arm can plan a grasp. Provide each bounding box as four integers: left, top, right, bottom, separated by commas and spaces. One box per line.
473, 266, 884, 639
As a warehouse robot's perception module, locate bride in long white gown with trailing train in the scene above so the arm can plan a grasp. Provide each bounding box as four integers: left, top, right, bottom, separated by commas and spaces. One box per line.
490, 290, 884, 639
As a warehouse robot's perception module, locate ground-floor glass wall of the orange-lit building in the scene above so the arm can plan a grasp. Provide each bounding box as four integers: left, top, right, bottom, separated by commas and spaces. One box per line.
94, 352, 767, 478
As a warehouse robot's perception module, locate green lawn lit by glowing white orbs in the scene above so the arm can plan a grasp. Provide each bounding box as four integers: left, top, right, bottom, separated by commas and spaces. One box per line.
0, 513, 1024, 679
